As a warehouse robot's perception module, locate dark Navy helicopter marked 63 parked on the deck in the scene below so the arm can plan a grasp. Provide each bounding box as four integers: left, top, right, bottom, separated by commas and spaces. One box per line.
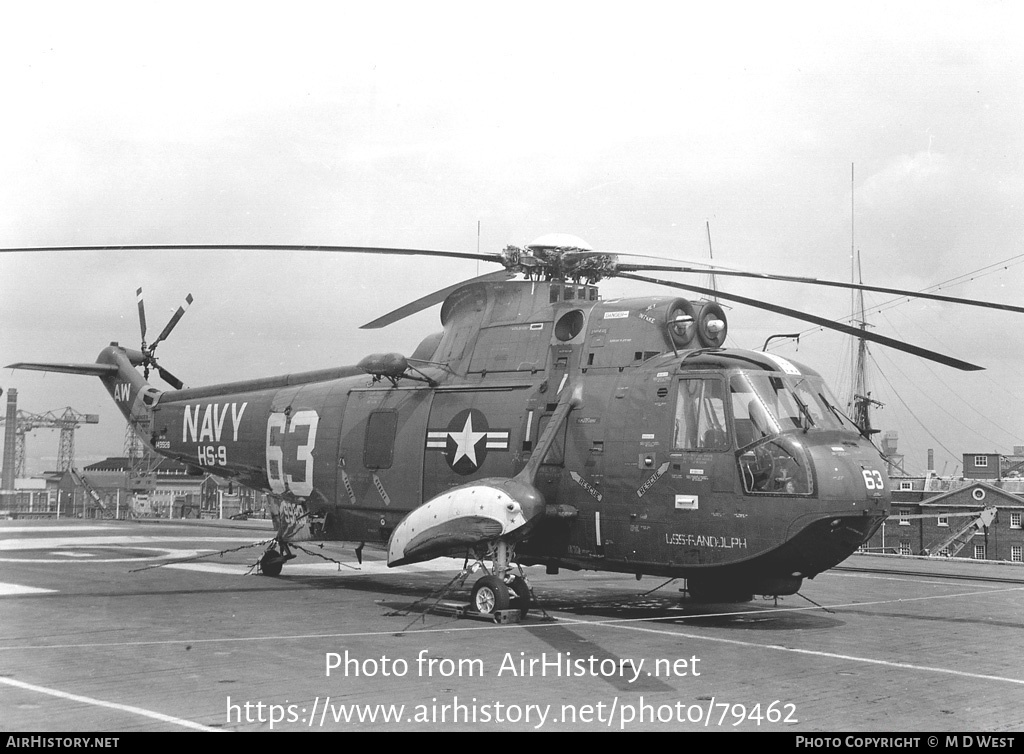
4, 235, 1024, 614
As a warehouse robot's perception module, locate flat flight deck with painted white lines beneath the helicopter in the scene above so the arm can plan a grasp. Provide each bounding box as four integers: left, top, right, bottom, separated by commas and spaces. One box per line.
0, 519, 1024, 736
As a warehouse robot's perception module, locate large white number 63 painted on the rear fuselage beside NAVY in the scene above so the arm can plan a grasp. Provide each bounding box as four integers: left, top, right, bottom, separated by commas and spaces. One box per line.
266, 411, 319, 498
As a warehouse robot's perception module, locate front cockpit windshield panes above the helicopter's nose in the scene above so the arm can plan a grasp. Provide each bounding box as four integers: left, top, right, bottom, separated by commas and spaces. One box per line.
729, 372, 857, 448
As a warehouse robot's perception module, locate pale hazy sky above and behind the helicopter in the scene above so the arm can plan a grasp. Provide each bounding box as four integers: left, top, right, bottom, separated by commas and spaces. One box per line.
0, 1, 1024, 473
